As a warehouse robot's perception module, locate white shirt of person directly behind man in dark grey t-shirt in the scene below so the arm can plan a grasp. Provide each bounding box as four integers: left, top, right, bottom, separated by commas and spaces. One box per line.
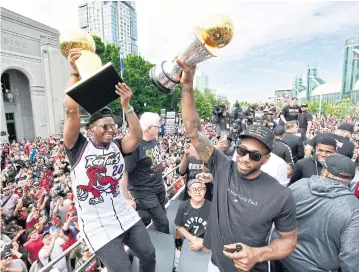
232, 153, 288, 186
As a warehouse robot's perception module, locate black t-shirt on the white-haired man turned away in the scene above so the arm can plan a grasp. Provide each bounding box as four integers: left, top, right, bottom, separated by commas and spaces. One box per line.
125, 140, 165, 194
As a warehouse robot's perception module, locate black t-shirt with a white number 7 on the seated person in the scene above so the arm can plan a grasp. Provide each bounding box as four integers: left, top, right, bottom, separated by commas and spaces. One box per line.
175, 199, 211, 238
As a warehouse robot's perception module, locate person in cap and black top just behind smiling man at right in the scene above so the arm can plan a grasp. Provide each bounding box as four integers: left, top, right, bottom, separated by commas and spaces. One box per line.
305, 123, 354, 159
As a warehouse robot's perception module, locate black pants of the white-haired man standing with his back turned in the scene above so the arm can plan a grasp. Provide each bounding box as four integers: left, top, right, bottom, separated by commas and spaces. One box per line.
131, 191, 169, 234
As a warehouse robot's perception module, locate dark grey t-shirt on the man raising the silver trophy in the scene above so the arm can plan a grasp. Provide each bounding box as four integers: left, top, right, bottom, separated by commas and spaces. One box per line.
204, 149, 297, 272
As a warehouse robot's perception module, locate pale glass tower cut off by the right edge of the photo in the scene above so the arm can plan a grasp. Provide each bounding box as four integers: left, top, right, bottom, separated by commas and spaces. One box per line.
342, 37, 359, 95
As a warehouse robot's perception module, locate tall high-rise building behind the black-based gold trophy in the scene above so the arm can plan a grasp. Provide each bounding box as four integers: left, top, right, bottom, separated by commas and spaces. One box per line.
78, 1, 138, 56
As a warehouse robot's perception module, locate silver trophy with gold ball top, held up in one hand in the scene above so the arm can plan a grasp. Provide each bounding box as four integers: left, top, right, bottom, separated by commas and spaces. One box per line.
150, 15, 234, 94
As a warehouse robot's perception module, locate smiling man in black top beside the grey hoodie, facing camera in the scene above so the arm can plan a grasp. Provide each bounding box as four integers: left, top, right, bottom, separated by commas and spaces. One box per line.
288, 136, 337, 186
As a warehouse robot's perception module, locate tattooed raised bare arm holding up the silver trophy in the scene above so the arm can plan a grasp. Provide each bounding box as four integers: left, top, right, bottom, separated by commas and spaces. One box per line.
177, 60, 214, 163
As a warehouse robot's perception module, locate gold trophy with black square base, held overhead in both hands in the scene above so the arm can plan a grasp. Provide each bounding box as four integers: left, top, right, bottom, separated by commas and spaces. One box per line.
59, 29, 123, 114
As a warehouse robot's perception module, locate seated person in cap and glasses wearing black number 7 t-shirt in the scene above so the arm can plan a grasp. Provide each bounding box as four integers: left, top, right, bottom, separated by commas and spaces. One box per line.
175, 179, 211, 252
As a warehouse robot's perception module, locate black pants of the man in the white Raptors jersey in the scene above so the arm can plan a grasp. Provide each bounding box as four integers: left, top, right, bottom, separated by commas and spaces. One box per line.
96, 220, 156, 272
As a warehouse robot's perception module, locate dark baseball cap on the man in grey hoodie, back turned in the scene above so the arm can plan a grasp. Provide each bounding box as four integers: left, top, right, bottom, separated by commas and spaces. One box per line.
324, 154, 355, 179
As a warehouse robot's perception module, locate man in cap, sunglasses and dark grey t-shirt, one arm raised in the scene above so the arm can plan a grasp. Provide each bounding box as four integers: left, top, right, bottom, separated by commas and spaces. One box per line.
176, 59, 297, 272
